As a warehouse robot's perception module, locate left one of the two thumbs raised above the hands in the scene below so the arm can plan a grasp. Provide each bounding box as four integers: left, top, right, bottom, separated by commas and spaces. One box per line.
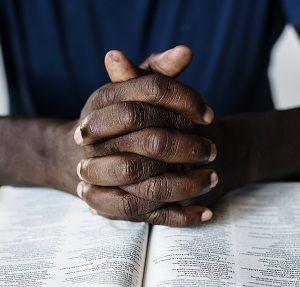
104, 50, 143, 83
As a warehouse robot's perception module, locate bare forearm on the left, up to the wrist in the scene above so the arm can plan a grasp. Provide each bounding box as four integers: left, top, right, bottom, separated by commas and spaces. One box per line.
0, 117, 78, 195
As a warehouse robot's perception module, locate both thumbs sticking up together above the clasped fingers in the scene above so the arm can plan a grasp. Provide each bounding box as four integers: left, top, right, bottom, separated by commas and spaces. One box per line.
104, 45, 192, 83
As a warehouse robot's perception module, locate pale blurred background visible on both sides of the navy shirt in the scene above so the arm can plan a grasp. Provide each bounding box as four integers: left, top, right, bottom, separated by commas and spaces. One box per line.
0, 26, 300, 115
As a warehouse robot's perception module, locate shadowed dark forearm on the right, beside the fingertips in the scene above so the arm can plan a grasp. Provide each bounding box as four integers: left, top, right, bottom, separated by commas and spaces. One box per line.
208, 109, 300, 189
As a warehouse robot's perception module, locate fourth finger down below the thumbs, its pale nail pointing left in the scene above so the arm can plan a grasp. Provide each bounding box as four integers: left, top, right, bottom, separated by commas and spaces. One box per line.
77, 154, 173, 186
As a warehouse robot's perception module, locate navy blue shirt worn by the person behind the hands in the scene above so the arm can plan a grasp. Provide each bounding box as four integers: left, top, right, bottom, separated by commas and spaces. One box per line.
0, 0, 300, 119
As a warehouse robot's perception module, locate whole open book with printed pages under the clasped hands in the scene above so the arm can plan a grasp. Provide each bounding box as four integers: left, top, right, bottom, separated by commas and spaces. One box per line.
0, 184, 300, 287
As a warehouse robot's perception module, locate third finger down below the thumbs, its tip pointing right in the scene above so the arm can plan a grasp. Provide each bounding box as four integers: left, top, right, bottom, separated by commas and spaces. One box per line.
89, 128, 217, 164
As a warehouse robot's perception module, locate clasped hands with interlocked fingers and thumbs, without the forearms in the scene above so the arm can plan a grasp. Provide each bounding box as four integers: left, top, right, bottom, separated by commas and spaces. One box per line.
74, 46, 236, 226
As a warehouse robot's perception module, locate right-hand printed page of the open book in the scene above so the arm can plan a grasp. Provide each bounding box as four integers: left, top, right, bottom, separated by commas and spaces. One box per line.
144, 184, 300, 287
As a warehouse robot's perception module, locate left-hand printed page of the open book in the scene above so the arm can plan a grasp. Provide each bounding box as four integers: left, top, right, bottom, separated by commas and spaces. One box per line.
0, 188, 148, 287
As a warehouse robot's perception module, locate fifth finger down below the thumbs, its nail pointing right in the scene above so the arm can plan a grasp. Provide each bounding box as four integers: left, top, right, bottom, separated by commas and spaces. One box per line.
121, 169, 218, 202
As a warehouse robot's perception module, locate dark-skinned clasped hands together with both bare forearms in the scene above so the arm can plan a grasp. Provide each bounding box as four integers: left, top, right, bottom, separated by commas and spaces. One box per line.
0, 27, 300, 226
